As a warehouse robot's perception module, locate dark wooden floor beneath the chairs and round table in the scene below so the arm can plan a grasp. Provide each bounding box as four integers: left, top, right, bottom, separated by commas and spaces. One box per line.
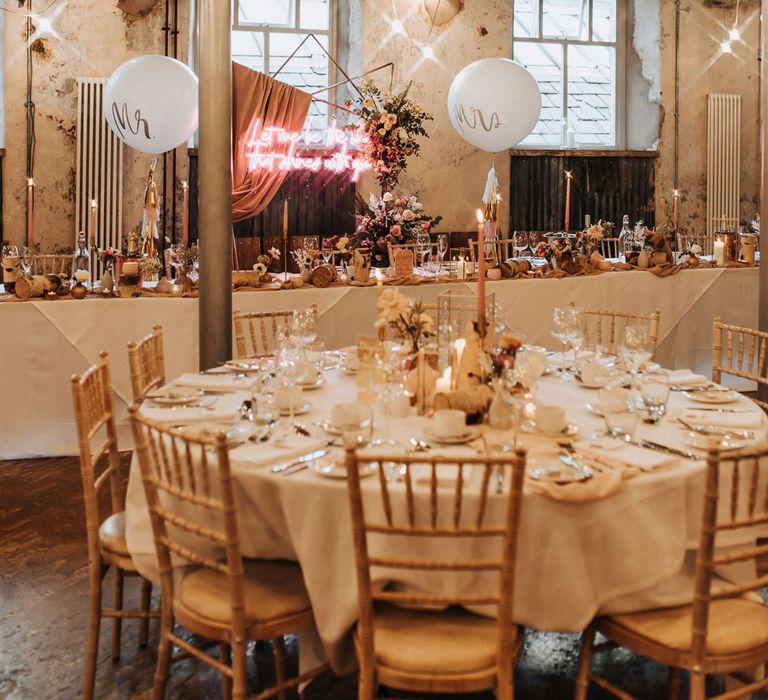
0, 459, 712, 700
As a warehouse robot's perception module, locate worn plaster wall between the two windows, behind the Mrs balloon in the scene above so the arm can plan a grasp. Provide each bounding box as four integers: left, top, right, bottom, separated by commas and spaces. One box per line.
359, 0, 512, 231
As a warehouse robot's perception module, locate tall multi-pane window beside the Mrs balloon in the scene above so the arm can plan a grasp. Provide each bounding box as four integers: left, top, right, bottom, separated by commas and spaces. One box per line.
512, 0, 625, 148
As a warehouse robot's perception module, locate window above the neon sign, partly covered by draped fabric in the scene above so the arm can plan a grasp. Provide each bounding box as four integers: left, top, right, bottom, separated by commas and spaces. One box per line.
232, 0, 335, 130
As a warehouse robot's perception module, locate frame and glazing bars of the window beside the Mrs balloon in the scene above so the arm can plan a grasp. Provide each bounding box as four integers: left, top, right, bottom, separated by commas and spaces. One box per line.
510, 0, 629, 151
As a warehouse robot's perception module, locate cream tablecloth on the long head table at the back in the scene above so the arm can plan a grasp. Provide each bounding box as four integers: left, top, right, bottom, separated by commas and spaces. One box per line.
0, 268, 758, 459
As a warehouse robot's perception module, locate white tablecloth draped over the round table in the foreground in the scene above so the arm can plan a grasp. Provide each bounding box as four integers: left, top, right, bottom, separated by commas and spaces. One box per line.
126, 372, 765, 672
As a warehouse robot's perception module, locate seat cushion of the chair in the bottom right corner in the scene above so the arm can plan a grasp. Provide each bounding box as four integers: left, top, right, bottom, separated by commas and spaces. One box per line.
608, 598, 768, 656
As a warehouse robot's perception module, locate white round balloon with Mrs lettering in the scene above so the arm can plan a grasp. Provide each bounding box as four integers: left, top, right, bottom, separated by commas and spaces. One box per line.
448, 58, 541, 153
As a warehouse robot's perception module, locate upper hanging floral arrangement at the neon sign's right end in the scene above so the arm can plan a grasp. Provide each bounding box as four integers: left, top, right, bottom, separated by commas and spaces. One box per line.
346, 81, 433, 191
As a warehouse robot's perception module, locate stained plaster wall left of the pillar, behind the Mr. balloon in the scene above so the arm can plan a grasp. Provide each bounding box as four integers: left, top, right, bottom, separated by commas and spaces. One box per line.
0, 0, 187, 250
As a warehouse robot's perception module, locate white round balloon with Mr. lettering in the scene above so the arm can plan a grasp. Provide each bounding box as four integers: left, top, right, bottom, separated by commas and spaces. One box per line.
104, 56, 198, 153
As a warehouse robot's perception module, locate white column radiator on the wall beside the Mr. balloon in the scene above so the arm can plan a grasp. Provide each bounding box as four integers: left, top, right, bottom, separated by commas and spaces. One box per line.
73, 78, 123, 276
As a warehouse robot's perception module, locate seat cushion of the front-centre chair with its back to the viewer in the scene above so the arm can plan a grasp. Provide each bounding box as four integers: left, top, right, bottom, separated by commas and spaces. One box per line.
366, 605, 510, 675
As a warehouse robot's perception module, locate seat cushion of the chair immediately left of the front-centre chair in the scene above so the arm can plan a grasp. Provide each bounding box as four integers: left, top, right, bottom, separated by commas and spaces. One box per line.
176, 560, 311, 624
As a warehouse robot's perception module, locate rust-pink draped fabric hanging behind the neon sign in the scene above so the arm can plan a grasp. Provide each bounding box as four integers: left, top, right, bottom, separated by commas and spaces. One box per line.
232, 63, 312, 222
